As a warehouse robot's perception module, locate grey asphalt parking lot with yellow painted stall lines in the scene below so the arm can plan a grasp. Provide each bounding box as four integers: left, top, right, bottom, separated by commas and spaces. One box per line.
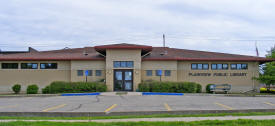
0, 95, 275, 113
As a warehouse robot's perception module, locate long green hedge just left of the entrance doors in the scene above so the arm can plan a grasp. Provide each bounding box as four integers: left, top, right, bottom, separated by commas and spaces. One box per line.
42, 81, 107, 94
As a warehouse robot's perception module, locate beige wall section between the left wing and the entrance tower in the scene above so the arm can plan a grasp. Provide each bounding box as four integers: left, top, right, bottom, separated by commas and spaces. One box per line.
71, 61, 105, 82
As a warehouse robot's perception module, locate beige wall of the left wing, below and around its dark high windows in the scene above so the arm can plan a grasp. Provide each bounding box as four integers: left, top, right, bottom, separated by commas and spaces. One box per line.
0, 61, 71, 93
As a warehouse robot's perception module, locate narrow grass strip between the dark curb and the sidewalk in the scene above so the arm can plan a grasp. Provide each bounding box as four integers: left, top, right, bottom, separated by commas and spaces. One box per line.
0, 112, 275, 120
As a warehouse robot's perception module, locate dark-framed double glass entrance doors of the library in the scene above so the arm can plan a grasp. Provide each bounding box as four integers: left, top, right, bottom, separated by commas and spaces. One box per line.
114, 70, 133, 91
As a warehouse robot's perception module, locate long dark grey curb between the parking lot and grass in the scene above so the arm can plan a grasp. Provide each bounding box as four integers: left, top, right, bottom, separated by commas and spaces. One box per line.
0, 109, 275, 117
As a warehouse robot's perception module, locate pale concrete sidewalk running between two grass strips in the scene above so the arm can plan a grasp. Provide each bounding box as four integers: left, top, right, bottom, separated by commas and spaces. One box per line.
0, 115, 275, 123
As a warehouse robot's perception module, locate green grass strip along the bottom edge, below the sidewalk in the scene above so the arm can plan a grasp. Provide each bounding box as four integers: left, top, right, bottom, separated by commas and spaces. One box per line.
0, 120, 275, 126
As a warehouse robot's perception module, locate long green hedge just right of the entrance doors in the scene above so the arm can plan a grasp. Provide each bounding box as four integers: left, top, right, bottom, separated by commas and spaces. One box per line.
138, 81, 201, 93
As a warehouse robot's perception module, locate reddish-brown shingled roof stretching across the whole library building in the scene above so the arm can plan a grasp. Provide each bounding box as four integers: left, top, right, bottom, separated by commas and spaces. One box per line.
0, 43, 275, 63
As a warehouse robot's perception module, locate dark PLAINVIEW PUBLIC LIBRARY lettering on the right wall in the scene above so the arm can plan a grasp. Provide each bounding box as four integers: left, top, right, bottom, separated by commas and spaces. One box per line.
189, 73, 247, 77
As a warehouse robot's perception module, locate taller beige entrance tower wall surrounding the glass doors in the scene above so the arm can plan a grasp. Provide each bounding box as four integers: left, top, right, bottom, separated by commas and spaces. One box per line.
106, 49, 141, 91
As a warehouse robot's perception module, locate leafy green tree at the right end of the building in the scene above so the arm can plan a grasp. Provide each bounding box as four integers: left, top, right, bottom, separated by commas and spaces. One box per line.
255, 45, 275, 92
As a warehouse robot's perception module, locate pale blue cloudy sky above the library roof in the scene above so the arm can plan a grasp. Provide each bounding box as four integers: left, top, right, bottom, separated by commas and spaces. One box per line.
0, 0, 275, 56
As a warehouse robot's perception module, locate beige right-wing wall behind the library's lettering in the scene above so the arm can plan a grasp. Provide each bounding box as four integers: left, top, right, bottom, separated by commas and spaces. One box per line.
178, 61, 259, 92
